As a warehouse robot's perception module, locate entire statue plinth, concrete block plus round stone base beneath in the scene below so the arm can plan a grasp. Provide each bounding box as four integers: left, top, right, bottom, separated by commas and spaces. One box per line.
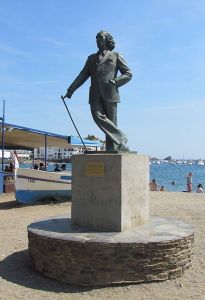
28, 153, 194, 286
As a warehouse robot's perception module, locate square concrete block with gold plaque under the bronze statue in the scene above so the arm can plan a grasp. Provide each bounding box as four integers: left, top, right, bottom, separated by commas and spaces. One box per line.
71, 152, 149, 232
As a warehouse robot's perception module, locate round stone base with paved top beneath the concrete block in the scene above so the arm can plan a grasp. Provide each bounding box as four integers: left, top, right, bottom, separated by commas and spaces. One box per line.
28, 216, 194, 286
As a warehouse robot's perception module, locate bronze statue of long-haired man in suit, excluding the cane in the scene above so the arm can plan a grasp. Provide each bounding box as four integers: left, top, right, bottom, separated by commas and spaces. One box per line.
64, 31, 132, 151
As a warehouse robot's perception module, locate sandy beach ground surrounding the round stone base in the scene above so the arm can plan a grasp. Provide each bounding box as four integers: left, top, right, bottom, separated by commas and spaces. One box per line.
0, 192, 205, 300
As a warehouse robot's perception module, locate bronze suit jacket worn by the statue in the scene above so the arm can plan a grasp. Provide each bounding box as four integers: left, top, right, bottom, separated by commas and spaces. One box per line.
68, 51, 132, 104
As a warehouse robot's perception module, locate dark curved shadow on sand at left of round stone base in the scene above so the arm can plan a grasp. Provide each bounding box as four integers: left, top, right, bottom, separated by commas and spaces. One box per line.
0, 250, 92, 293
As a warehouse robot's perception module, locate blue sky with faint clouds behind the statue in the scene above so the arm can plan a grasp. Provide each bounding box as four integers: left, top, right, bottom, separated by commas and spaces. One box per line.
0, 0, 205, 159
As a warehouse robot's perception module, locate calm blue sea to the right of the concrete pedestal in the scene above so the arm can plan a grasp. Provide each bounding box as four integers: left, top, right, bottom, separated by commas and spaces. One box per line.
150, 163, 205, 192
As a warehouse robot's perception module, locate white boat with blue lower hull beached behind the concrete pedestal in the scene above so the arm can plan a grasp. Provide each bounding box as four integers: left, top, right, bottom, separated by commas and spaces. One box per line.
15, 168, 72, 203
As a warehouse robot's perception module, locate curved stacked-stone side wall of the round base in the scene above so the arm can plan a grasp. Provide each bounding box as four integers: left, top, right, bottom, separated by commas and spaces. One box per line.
28, 218, 194, 286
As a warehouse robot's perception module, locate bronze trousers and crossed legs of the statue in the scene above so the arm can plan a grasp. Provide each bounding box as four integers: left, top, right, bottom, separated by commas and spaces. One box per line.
90, 97, 127, 151
